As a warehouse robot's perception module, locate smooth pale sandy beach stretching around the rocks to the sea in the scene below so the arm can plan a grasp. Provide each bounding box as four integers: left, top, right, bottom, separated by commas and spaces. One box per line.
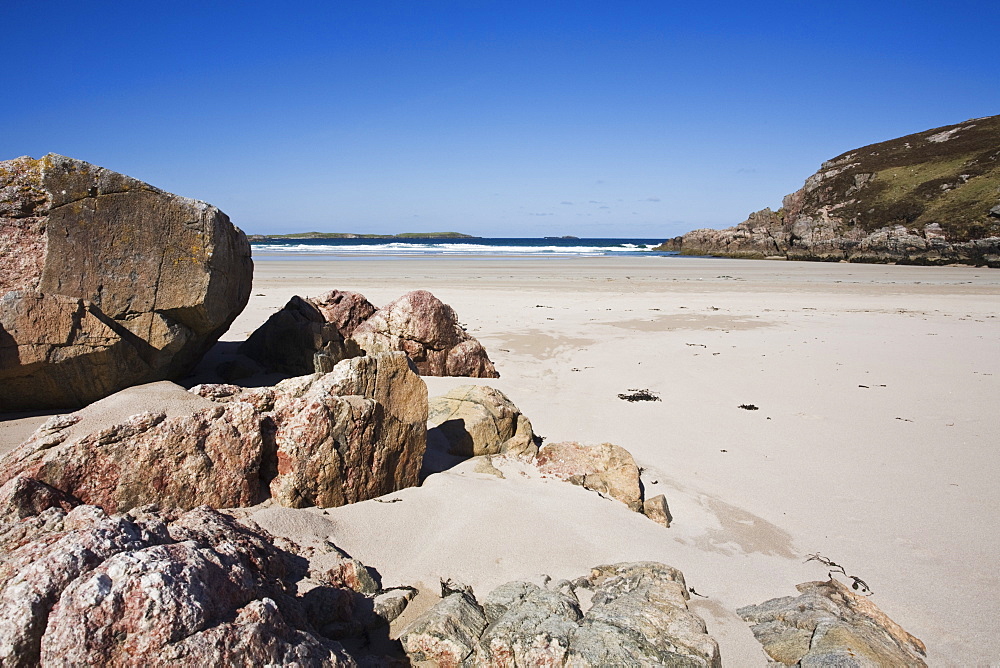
0, 257, 1000, 666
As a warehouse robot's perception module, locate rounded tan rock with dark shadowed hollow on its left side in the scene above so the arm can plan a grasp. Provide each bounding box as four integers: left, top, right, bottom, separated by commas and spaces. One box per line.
427, 385, 538, 457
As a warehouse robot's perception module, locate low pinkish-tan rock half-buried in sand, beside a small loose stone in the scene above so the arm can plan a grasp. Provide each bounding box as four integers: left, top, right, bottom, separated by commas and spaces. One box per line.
537, 441, 642, 512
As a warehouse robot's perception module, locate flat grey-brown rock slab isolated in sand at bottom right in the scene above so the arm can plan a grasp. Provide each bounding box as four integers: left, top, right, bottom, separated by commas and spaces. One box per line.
737, 579, 927, 666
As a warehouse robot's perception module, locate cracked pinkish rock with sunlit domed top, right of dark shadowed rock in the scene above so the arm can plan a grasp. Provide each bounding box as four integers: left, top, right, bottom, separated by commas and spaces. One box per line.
352, 290, 499, 378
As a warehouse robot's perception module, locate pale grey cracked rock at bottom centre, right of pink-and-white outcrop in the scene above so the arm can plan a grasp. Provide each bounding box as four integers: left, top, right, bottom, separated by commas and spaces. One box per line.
400, 562, 721, 667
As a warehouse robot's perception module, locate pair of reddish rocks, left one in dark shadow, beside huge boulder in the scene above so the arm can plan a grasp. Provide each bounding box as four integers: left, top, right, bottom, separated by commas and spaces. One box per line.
239, 290, 499, 378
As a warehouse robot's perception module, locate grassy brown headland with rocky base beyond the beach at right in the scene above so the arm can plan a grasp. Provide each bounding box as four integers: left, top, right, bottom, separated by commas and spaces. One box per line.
659, 116, 1000, 267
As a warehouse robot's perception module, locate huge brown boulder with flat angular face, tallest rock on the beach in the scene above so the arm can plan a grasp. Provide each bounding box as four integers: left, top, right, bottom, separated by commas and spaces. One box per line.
0, 154, 253, 410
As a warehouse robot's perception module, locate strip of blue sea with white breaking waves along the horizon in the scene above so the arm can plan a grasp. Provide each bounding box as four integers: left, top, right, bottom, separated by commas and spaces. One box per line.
250, 238, 675, 260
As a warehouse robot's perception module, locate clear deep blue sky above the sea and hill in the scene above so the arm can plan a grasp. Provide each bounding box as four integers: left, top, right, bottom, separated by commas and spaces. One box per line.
0, 0, 1000, 238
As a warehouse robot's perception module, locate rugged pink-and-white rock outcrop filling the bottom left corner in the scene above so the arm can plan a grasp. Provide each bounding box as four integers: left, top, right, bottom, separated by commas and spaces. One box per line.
0, 505, 422, 667
